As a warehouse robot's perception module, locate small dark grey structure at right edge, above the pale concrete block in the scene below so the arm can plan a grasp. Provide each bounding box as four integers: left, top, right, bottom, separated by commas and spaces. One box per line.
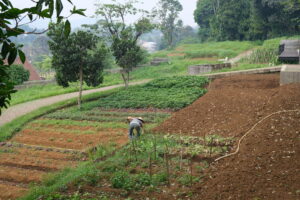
279, 40, 300, 62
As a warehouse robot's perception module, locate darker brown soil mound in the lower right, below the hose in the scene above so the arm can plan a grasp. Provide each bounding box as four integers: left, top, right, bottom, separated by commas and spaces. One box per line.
195, 112, 300, 200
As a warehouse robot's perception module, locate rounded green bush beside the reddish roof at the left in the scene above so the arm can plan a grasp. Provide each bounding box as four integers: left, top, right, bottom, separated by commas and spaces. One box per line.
7, 65, 30, 85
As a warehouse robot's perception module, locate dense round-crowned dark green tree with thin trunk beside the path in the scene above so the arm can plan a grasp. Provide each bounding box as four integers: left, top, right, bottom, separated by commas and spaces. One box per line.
48, 24, 108, 109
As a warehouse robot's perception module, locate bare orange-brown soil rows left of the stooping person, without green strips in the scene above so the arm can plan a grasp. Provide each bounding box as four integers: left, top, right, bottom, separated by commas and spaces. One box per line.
0, 120, 128, 200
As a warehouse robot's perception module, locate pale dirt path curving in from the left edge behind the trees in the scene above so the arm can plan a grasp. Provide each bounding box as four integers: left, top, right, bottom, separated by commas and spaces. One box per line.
0, 80, 149, 126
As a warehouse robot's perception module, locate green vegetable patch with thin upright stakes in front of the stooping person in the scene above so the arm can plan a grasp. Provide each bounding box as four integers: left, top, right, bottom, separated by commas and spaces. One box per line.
35, 134, 233, 199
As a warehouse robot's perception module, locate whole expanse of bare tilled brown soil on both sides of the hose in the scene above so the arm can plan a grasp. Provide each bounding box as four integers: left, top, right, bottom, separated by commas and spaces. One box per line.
155, 74, 300, 200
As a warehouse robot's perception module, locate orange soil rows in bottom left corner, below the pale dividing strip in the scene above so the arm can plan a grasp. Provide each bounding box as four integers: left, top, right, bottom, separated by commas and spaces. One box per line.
0, 143, 78, 199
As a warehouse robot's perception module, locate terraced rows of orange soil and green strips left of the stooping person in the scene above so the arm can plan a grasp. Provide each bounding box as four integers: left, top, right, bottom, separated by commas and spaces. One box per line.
0, 108, 170, 200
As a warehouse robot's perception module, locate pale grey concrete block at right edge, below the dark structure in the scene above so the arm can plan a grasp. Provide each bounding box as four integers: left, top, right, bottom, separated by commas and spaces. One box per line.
280, 65, 300, 85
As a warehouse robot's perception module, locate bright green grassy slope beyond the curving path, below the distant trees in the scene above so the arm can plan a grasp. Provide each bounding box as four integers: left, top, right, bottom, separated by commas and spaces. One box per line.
11, 36, 299, 105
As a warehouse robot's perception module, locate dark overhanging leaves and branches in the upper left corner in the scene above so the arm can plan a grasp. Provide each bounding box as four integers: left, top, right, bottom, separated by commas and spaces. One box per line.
0, 0, 84, 114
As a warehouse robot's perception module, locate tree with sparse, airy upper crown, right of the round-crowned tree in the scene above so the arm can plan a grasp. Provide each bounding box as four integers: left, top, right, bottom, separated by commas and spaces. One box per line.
93, 1, 154, 88
